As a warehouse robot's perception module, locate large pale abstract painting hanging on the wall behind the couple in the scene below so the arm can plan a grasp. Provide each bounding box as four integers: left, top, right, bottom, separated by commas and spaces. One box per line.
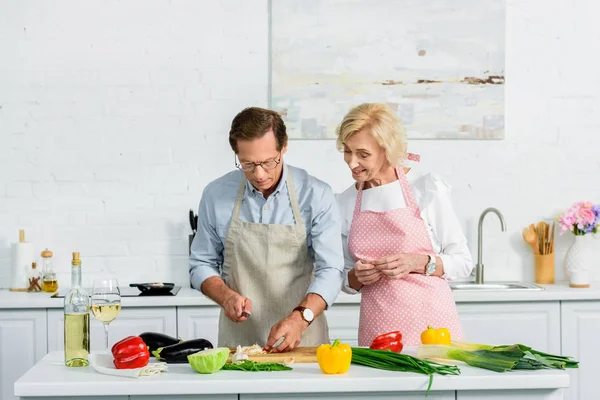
270, 0, 505, 139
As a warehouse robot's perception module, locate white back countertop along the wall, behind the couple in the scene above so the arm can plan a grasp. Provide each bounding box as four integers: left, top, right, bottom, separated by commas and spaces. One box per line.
0, 282, 600, 309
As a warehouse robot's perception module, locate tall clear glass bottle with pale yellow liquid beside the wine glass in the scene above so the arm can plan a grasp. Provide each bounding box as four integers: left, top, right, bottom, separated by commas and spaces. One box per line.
65, 252, 90, 367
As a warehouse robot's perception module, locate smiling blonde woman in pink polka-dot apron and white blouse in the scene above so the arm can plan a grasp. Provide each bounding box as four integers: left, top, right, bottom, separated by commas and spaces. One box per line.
337, 104, 473, 346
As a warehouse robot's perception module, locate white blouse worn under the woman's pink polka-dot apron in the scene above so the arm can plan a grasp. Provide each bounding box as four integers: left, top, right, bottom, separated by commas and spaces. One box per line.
336, 167, 473, 294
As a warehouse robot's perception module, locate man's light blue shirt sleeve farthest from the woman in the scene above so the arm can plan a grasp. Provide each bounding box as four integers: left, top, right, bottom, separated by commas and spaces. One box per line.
189, 186, 223, 290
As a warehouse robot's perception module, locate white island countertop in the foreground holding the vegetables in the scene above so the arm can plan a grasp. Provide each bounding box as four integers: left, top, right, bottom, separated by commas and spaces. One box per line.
14, 352, 570, 399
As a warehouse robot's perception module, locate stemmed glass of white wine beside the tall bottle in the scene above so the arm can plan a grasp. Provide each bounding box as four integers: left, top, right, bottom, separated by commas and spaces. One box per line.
92, 279, 121, 353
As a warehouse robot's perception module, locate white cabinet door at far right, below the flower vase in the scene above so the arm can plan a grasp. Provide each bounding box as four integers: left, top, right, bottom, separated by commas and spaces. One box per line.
561, 301, 600, 400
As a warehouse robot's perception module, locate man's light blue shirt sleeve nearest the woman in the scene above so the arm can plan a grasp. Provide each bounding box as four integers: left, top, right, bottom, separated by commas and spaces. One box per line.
307, 185, 344, 307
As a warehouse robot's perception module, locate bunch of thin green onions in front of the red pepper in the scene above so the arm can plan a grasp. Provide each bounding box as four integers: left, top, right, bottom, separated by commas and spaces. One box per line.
352, 347, 460, 395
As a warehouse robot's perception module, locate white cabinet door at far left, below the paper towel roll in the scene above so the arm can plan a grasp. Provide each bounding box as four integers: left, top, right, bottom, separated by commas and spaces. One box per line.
0, 309, 48, 400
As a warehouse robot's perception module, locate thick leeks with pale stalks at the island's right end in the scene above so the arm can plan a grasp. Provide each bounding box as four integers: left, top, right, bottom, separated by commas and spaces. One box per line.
417, 340, 578, 372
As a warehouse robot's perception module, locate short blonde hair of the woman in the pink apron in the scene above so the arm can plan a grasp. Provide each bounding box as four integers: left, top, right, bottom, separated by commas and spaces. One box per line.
337, 103, 406, 165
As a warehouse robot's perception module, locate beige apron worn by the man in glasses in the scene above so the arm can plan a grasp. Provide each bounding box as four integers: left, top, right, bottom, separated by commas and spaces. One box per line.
218, 173, 329, 347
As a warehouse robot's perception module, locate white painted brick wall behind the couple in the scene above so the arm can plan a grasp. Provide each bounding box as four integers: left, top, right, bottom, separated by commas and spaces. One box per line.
0, 0, 600, 287
